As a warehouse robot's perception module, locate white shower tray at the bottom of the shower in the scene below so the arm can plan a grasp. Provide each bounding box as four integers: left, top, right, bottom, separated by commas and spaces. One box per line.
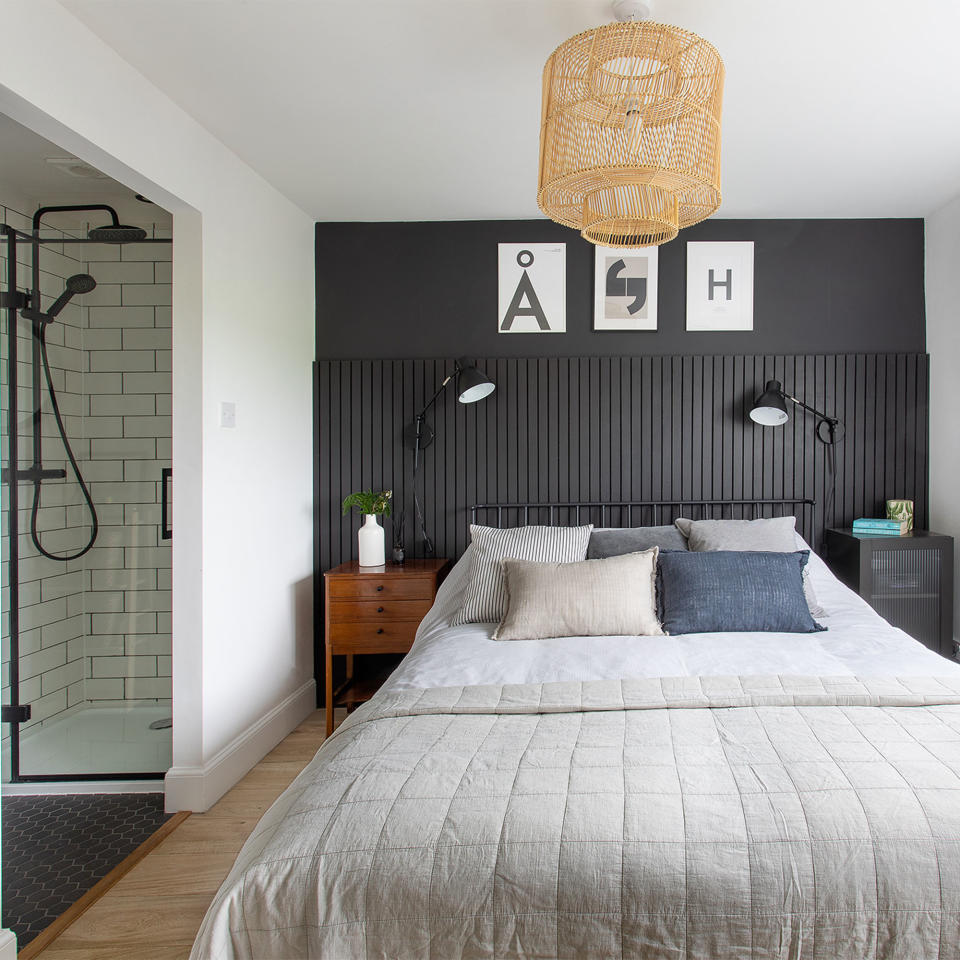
3, 702, 173, 779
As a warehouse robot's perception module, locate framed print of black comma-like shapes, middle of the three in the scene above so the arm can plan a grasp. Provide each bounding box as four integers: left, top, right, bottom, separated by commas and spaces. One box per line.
593, 246, 659, 330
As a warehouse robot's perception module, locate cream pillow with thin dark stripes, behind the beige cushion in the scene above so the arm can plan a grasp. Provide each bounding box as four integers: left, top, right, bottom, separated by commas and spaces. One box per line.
453, 523, 593, 626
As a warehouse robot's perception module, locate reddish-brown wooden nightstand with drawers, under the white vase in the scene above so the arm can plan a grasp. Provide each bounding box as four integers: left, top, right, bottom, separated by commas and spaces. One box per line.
323, 559, 450, 737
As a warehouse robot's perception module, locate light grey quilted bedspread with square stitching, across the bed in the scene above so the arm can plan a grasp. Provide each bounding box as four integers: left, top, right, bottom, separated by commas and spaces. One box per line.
192, 677, 960, 960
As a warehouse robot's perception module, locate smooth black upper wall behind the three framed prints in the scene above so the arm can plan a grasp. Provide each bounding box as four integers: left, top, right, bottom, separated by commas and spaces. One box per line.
316, 219, 926, 359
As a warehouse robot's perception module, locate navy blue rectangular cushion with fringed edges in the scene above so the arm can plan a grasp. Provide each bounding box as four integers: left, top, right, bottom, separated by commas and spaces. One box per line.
657, 550, 825, 634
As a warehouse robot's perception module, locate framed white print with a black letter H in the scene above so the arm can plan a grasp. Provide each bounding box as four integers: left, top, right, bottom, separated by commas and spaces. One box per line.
687, 240, 753, 330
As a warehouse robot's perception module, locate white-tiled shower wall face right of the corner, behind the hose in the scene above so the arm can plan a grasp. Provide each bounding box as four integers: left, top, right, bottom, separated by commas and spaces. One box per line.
83, 232, 172, 700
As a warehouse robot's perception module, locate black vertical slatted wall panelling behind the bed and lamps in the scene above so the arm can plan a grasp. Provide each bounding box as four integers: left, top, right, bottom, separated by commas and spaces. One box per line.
315, 352, 928, 570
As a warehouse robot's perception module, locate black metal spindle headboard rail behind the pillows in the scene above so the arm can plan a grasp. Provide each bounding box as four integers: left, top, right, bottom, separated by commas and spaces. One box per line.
470, 497, 816, 540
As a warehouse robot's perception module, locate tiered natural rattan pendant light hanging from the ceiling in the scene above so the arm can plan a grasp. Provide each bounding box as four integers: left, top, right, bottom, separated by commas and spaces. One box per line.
537, 0, 724, 247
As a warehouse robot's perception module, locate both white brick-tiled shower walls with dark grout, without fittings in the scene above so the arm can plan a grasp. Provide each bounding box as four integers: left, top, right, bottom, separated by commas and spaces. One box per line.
0, 201, 171, 734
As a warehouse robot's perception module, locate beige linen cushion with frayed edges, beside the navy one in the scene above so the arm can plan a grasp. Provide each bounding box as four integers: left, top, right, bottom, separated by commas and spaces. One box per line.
493, 547, 663, 640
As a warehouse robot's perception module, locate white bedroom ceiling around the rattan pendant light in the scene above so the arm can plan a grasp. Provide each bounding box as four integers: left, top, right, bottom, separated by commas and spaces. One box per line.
56, 0, 960, 220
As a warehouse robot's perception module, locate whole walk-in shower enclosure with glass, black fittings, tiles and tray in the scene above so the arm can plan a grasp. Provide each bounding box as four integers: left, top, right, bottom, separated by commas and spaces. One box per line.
0, 198, 172, 783
